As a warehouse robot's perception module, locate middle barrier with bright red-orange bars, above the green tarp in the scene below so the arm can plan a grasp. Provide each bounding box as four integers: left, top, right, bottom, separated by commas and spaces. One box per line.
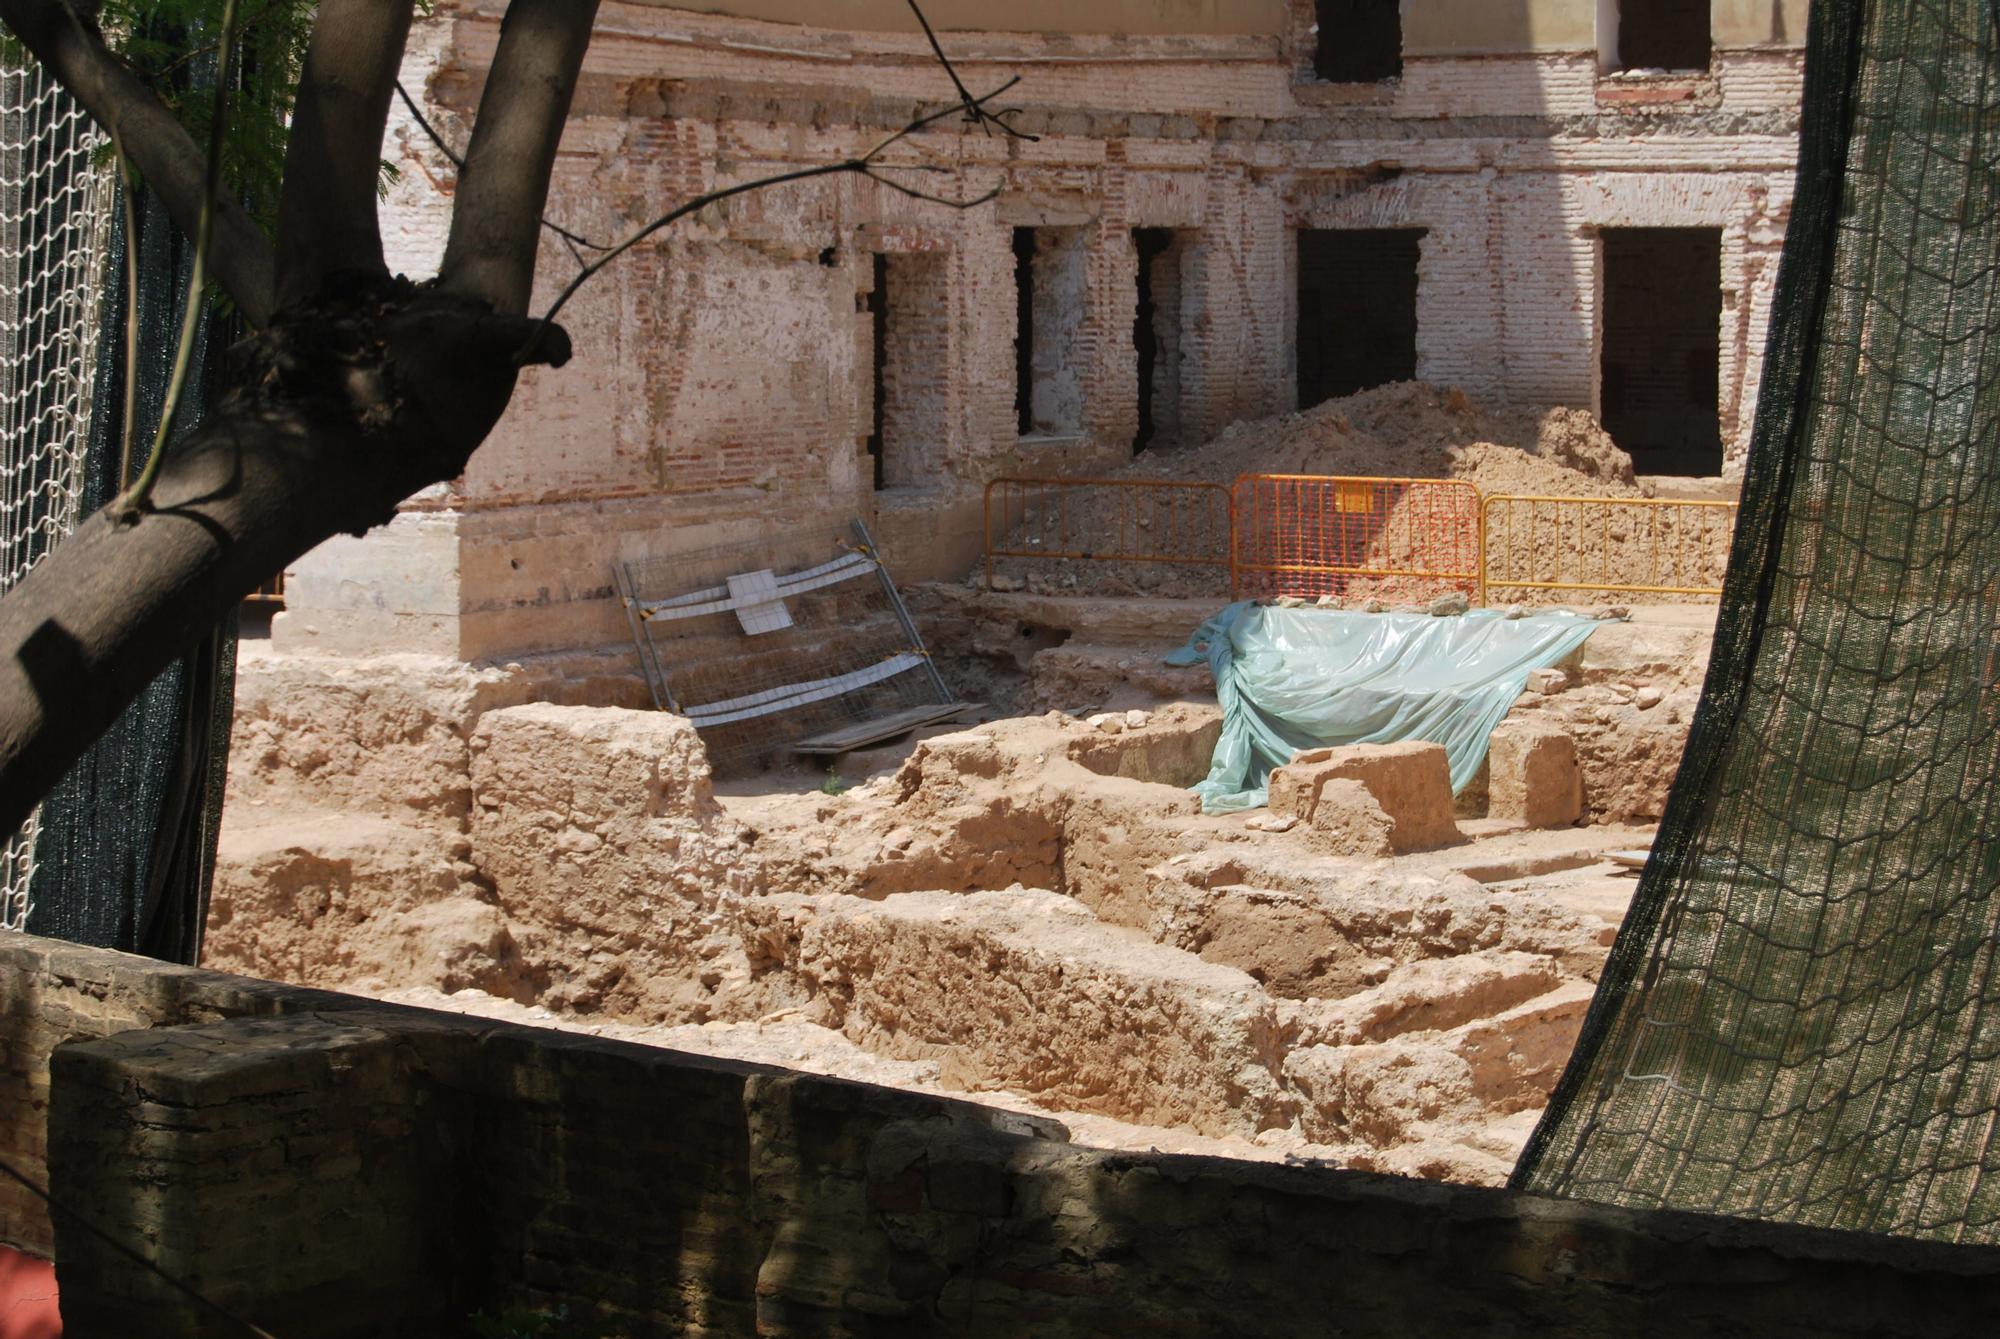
1230, 474, 1482, 600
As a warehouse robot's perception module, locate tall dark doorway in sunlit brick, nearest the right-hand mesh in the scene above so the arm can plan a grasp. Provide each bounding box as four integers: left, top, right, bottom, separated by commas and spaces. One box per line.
1602, 228, 1722, 474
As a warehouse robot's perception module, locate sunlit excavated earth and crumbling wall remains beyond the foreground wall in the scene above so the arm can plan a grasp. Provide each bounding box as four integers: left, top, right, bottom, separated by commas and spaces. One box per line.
206, 599, 1710, 1183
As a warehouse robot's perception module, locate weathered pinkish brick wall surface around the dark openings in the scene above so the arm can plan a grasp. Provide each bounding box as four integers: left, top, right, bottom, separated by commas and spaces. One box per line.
276, 0, 1800, 660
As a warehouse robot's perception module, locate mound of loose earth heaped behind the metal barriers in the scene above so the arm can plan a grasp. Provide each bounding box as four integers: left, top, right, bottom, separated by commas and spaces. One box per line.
972, 382, 1734, 608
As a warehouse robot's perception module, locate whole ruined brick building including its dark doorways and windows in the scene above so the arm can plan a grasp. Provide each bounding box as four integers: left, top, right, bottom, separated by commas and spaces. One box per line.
276, 0, 1806, 660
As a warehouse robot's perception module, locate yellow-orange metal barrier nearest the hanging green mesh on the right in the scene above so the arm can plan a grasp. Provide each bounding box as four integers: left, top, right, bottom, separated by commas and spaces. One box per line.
1482, 494, 1736, 600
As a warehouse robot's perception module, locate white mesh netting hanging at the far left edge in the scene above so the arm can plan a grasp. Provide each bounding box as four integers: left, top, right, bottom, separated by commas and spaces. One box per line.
0, 58, 112, 929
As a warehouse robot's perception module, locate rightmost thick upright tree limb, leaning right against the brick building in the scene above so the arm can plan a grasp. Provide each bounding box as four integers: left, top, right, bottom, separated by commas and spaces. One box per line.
438, 0, 598, 316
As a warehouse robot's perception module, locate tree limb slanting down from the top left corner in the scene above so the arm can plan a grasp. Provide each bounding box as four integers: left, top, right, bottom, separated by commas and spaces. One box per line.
0, 0, 276, 326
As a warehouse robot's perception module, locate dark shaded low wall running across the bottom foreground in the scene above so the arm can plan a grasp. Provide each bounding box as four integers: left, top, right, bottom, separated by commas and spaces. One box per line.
0, 935, 2000, 1339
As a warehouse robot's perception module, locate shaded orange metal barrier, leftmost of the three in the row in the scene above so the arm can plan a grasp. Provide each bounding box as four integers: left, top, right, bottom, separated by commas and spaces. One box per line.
986, 478, 1230, 588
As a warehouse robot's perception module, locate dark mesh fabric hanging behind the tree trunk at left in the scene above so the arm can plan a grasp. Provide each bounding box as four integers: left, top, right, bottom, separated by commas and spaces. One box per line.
28, 177, 236, 963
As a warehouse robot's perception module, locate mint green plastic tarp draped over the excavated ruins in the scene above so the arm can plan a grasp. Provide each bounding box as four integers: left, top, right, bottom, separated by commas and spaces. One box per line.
1166, 604, 1598, 813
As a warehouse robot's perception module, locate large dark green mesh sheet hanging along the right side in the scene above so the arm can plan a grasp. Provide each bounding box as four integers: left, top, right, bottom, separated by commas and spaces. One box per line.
1514, 0, 2000, 1243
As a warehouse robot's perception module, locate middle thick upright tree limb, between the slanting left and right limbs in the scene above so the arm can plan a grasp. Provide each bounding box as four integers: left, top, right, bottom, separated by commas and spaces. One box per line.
278, 0, 416, 306
